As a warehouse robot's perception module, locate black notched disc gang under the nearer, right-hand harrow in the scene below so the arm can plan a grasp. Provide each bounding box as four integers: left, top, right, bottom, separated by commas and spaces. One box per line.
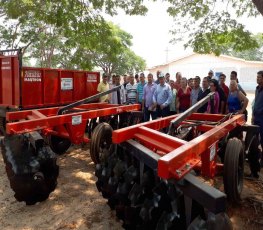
95, 143, 231, 230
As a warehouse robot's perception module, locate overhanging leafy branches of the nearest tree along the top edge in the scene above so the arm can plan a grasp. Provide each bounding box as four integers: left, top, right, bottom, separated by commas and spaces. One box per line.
0, 0, 263, 60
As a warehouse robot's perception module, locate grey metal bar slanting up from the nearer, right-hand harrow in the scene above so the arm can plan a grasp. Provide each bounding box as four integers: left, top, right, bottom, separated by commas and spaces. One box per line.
168, 92, 215, 135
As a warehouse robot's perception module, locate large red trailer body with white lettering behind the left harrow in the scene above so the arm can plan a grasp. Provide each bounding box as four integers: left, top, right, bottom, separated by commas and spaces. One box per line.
0, 52, 100, 110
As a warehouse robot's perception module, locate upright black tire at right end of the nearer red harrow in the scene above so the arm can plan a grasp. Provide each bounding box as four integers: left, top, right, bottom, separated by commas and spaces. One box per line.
223, 138, 244, 203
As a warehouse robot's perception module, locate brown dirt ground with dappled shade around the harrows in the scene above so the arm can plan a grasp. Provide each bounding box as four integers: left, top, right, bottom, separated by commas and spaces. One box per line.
0, 92, 263, 230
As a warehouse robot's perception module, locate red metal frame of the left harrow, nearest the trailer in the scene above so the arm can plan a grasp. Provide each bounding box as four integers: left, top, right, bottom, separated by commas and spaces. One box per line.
6, 103, 140, 144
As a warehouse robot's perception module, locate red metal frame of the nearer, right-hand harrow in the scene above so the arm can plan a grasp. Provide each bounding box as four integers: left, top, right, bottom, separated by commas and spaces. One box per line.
112, 113, 245, 179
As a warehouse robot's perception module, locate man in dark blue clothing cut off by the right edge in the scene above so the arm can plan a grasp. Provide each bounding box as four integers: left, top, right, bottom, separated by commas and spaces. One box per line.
252, 70, 263, 166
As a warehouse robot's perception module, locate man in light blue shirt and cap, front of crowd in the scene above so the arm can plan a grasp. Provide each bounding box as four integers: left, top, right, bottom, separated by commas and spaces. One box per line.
153, 73, 172, 117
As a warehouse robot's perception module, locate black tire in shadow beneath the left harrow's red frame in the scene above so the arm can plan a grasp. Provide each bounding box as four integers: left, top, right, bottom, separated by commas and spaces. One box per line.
48, 135, 71, 155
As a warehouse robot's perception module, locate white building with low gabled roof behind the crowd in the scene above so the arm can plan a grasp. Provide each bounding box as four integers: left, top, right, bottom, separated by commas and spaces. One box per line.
147, 53, 263, 90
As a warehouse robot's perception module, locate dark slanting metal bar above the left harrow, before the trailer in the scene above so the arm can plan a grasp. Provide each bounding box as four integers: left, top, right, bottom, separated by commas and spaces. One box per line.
57, 85, 122, 115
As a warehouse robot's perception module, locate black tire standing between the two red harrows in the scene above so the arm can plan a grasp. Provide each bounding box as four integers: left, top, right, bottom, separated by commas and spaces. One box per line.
90, 122, 113, 164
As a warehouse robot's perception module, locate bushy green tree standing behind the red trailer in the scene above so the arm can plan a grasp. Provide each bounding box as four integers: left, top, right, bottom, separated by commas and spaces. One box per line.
0, 2, 145, 74
